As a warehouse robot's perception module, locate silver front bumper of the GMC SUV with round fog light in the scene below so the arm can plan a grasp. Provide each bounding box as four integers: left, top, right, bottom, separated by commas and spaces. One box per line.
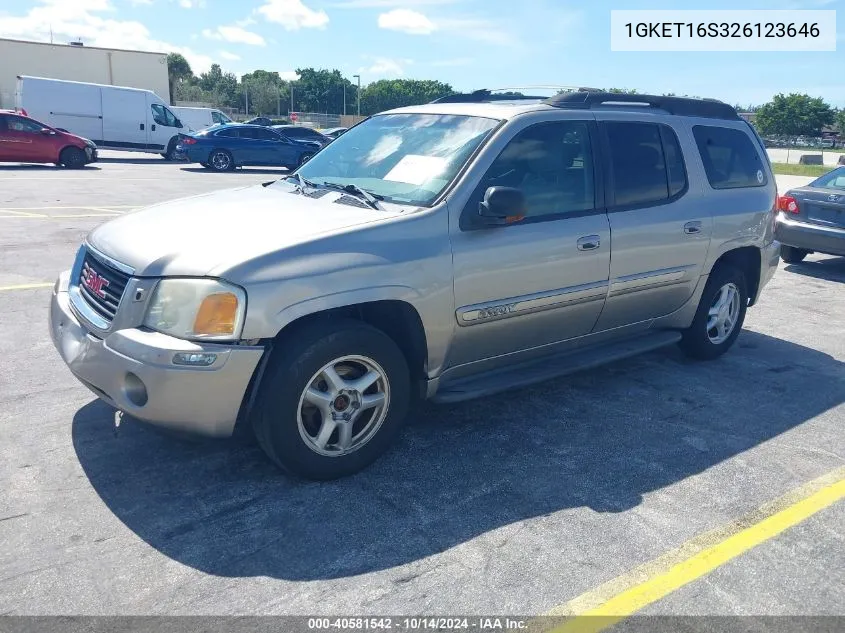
50, 273, 264, 437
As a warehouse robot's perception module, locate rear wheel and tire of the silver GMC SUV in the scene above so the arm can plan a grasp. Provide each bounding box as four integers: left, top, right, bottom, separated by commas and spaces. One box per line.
680, 264, 748, 360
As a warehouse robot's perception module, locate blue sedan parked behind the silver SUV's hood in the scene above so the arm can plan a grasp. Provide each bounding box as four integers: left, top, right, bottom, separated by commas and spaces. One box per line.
175, 123, 321, 171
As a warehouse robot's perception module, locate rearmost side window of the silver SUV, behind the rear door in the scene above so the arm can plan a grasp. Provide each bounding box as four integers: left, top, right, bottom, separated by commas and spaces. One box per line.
692, 125, 767, 189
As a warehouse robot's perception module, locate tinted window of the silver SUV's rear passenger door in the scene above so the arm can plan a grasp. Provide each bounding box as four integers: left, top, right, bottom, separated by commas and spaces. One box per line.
604, 121, 687, 207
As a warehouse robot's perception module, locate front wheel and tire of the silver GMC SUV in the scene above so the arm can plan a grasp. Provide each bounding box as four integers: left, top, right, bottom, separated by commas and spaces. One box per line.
252, 319, 411, 480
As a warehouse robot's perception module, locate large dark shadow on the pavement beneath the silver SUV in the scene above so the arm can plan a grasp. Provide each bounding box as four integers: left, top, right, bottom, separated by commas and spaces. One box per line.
73, 331, 845, 580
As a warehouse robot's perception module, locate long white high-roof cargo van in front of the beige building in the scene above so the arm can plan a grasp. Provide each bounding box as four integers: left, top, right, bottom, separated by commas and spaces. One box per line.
15, 75, 183, 159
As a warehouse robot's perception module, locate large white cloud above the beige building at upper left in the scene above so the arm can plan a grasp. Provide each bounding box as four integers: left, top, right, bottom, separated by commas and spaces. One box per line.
0, 0, 213, 73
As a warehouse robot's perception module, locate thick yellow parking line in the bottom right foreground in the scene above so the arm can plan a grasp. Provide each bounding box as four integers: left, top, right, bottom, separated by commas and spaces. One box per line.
546, 467, 845, 633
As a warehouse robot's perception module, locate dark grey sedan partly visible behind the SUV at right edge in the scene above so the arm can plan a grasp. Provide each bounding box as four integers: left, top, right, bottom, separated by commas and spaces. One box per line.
775, 166, 845, 264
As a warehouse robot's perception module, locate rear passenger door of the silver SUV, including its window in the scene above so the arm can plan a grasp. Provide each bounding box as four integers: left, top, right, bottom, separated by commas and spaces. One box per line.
596, 113, 713, 331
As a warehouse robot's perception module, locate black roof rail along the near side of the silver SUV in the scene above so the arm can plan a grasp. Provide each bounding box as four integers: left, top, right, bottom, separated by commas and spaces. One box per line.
545, 90, 740, 120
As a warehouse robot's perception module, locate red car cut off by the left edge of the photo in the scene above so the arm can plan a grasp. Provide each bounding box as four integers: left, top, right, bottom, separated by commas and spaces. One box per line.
0, 110, 97, 169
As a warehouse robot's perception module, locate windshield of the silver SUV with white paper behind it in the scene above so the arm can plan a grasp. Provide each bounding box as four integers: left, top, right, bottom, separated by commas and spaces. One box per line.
297, 114, 499, 206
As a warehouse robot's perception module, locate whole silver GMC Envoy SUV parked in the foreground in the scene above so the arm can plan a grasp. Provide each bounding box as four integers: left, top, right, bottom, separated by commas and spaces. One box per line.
50, 90, 780, 479
